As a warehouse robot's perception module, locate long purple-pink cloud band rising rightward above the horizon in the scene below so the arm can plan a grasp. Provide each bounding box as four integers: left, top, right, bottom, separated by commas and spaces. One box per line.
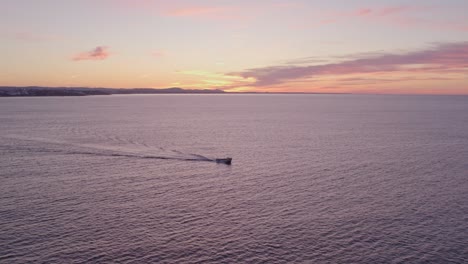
229, 42, 468, 86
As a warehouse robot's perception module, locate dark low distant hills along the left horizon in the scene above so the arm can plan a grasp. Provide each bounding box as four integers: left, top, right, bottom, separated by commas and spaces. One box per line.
0, 86, 225, 97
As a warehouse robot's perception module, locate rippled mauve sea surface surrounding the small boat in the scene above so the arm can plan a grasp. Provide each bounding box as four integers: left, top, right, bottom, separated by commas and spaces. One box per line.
0, 95, 468, 263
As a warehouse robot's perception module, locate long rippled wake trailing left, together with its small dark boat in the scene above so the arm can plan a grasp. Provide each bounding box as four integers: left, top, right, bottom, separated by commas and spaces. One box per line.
2, 135, 231, 165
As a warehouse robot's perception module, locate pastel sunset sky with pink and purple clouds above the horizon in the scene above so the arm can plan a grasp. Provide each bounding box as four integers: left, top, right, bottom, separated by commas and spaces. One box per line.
0, 0, 468, 94
